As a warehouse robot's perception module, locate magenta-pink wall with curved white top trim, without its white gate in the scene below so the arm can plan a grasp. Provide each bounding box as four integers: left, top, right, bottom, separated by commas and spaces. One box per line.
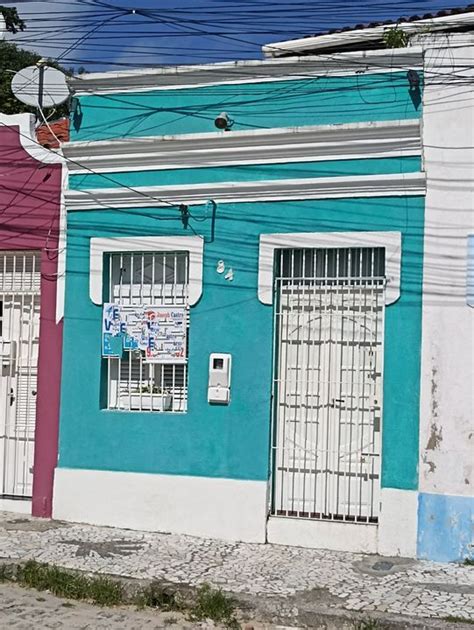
0, 114, 63, 517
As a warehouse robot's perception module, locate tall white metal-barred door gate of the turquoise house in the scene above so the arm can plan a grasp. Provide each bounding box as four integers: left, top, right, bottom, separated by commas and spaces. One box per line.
271, 248, 385, 523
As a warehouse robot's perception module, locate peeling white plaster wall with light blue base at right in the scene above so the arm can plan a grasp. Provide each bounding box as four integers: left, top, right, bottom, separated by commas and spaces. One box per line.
418, 38, 474, 560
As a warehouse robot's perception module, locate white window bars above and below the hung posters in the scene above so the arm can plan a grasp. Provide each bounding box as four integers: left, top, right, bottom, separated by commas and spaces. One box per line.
104, 252, 189, 412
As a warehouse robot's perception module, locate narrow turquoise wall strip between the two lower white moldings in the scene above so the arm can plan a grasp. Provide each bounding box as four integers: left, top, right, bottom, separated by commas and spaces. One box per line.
69, 156, 421, 190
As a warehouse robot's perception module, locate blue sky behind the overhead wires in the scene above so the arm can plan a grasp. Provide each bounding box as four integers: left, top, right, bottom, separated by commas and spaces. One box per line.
0, 0, 469, 72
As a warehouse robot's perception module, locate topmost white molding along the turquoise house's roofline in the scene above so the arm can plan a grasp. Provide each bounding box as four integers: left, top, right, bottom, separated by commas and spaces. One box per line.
68, 47, 423, 96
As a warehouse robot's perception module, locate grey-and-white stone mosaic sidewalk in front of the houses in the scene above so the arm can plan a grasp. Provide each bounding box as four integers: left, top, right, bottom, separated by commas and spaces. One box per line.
0, 512, 474, 628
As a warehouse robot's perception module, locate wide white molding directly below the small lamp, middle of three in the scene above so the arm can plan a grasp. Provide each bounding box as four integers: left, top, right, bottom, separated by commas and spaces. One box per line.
62, 119, 421, 175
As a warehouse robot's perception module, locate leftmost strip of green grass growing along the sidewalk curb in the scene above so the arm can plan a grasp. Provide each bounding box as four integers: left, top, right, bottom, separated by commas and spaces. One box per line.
17, 560, 124, 606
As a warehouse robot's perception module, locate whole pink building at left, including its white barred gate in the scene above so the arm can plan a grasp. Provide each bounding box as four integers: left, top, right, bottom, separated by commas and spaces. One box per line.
0, 114, 65, 517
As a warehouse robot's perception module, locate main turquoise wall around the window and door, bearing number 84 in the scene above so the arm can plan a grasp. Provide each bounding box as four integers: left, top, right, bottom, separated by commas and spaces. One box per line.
59, 197, 424, 489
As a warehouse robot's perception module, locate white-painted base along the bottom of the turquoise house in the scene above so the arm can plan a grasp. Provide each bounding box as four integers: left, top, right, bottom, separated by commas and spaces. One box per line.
50, 468, 418, 558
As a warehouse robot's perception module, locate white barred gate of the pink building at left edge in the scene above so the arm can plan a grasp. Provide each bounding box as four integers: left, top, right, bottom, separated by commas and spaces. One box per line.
0, 252, 41, 498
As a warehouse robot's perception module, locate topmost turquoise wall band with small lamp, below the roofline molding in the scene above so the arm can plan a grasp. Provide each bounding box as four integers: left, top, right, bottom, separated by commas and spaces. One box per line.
71, 72, 420, 141
